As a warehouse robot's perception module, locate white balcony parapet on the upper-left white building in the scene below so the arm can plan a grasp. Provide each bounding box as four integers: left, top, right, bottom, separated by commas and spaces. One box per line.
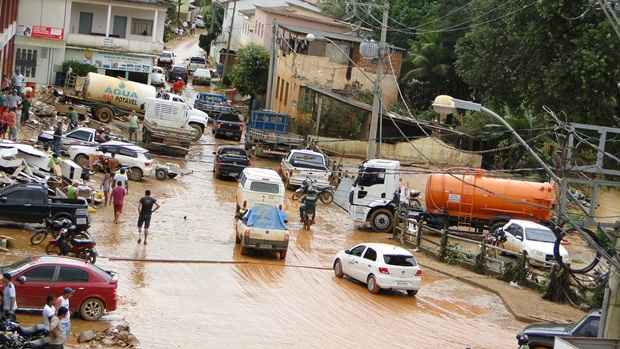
66, 33, 164, 54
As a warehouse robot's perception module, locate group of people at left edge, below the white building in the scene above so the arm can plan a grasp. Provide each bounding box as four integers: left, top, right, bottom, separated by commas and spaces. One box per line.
0, 72, 32, 141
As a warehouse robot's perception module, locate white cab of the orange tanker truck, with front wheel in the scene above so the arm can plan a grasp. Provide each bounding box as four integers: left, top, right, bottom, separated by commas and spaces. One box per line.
349, 159, 400, 233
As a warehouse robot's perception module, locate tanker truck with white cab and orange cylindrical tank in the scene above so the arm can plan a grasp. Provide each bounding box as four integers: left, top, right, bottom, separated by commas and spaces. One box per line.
349, 159, 555, 232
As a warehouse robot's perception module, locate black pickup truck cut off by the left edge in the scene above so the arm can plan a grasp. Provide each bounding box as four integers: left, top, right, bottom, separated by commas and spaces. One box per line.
0, 183, 90, 229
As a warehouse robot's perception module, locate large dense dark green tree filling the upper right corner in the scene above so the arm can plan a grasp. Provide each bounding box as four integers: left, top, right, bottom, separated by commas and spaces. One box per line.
456, 0, 620, 125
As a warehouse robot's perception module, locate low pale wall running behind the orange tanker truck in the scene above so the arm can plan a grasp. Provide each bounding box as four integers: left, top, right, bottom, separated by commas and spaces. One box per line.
317, 137, 482, 168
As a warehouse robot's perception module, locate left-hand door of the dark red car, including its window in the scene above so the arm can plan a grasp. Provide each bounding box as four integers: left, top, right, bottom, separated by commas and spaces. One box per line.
15, 264, 59, 309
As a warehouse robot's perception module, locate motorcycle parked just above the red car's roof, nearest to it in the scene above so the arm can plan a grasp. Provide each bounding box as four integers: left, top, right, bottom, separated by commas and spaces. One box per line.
45, 225, 97, 264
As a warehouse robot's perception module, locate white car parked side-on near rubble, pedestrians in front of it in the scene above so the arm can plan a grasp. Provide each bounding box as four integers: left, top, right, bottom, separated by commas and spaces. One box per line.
67, 141, 155, 181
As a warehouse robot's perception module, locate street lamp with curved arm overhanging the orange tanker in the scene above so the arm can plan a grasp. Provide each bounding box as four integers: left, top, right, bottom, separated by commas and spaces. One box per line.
433, 95, 560, 183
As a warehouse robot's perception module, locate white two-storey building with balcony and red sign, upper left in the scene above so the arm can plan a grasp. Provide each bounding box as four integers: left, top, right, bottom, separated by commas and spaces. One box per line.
15, 0, 166, 84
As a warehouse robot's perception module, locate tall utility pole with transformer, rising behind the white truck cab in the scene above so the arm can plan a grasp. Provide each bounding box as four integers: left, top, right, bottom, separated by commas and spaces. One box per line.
367, 0, 390, 159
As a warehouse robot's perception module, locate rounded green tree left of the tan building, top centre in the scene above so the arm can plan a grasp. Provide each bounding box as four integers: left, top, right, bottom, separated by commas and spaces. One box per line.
231, 44, 269, 96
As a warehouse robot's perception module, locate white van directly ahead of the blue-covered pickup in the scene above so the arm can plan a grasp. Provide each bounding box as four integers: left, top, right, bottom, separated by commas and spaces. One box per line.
237, 167, 285, 213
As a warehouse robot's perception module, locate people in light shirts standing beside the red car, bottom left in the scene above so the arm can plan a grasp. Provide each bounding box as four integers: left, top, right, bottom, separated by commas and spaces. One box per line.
2, 273, 74, 349
